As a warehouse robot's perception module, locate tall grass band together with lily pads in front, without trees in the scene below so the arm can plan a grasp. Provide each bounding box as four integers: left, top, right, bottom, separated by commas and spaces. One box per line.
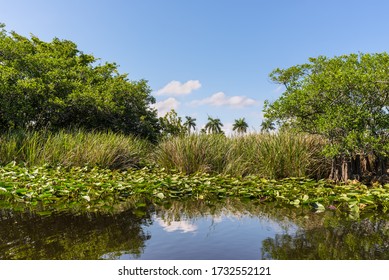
0, 130, 389, 217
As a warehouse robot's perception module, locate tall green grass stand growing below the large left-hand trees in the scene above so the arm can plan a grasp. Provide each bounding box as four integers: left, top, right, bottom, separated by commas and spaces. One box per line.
0, 130, 150, 169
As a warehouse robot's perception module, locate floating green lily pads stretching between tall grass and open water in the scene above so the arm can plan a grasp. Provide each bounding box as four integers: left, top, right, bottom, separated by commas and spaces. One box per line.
0, 164, 389, 213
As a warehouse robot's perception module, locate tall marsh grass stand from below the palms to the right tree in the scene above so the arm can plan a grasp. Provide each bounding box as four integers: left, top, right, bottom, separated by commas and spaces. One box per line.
156, 132, 329, 178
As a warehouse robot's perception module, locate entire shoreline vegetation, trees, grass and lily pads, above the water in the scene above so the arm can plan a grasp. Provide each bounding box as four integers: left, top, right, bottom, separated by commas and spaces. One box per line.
0, 23, 389, 215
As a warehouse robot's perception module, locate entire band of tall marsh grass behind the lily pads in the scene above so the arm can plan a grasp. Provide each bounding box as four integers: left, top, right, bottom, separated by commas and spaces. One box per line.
0, 130, 330, 179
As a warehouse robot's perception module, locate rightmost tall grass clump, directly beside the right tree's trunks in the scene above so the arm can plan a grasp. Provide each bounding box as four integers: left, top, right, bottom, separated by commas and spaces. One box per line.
225, 132, 329, 179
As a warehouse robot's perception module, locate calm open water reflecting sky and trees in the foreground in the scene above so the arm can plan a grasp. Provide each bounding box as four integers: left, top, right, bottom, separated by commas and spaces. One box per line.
0, 199, 389, 260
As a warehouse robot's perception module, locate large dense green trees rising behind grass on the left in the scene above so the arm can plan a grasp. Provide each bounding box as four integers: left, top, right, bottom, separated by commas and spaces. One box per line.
0, 25, 159, 140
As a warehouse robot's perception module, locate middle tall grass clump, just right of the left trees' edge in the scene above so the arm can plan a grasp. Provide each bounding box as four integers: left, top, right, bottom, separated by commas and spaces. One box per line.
155, 134, 229, 174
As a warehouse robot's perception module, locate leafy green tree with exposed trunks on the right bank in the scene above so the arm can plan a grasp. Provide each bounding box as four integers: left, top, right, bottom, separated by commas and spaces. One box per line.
264, 53, 389, 181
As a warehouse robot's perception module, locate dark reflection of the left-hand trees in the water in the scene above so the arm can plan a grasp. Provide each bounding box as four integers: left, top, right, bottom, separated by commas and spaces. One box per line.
0, 209, 150, 259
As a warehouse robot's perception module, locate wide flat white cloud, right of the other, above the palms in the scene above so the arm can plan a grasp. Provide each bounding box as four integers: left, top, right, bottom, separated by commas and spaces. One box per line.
190, 92, 257, 107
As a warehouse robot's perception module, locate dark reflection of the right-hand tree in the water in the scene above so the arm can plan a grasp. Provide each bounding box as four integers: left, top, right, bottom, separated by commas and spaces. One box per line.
262, 219, 389, 260
